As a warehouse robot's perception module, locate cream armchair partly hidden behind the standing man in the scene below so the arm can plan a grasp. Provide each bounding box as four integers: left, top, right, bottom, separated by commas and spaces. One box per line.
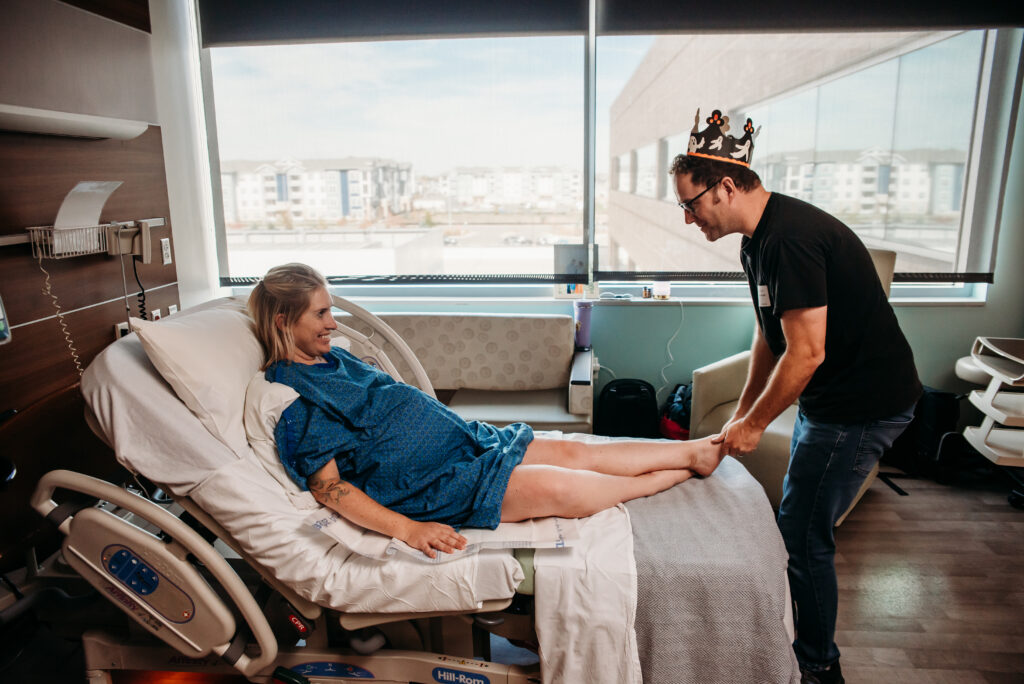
690, 250, 896, 526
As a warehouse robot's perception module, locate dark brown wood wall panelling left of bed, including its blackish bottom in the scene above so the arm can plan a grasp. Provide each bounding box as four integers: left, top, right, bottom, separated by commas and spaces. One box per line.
0, 126, 179, 569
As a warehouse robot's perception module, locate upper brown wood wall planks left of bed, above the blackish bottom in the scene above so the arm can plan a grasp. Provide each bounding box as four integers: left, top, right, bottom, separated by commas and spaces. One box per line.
0, 126, 178, 411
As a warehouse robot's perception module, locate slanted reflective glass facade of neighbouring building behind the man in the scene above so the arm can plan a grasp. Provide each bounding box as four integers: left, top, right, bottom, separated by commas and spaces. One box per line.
745, 31, 985, 272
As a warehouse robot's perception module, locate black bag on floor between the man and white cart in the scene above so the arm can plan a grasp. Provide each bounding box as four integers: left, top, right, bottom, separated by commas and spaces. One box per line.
882, 387, 961, 477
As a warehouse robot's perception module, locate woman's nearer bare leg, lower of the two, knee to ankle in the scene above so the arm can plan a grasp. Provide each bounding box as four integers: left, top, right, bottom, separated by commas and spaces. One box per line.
502, 464, 693, 522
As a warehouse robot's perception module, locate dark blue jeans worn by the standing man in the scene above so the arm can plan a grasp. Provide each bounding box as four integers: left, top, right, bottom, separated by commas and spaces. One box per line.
778, 407, 913, 671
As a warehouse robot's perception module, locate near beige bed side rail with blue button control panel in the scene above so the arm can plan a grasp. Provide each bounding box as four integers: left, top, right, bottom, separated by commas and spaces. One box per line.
32, 470, 278, 677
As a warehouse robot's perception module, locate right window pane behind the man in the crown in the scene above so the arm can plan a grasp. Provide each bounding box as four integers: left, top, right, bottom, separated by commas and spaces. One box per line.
596, 31, 984, 272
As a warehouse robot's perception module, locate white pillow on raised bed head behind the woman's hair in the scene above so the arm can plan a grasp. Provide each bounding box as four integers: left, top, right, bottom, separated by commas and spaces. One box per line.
131, 299, 263, 458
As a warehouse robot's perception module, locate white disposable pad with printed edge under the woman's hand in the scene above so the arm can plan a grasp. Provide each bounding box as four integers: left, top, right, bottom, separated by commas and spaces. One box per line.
305, 509, 580, 563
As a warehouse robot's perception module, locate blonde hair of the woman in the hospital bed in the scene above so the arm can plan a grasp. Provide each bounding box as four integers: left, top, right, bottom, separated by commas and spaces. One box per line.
248, 263, 327, 369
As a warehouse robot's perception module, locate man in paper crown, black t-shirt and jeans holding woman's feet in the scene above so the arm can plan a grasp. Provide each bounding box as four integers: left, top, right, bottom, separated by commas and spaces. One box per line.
671, 110, 922, 684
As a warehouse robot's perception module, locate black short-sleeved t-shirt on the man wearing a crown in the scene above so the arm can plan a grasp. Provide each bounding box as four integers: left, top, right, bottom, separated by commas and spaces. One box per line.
740, 193, 922, 423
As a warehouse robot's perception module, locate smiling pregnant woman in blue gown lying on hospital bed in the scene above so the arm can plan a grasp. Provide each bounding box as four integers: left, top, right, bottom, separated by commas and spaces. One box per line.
249, 263, 722, 558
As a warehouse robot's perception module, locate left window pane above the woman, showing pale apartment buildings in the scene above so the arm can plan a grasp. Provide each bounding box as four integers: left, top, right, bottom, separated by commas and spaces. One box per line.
211, 37, 584, 275
